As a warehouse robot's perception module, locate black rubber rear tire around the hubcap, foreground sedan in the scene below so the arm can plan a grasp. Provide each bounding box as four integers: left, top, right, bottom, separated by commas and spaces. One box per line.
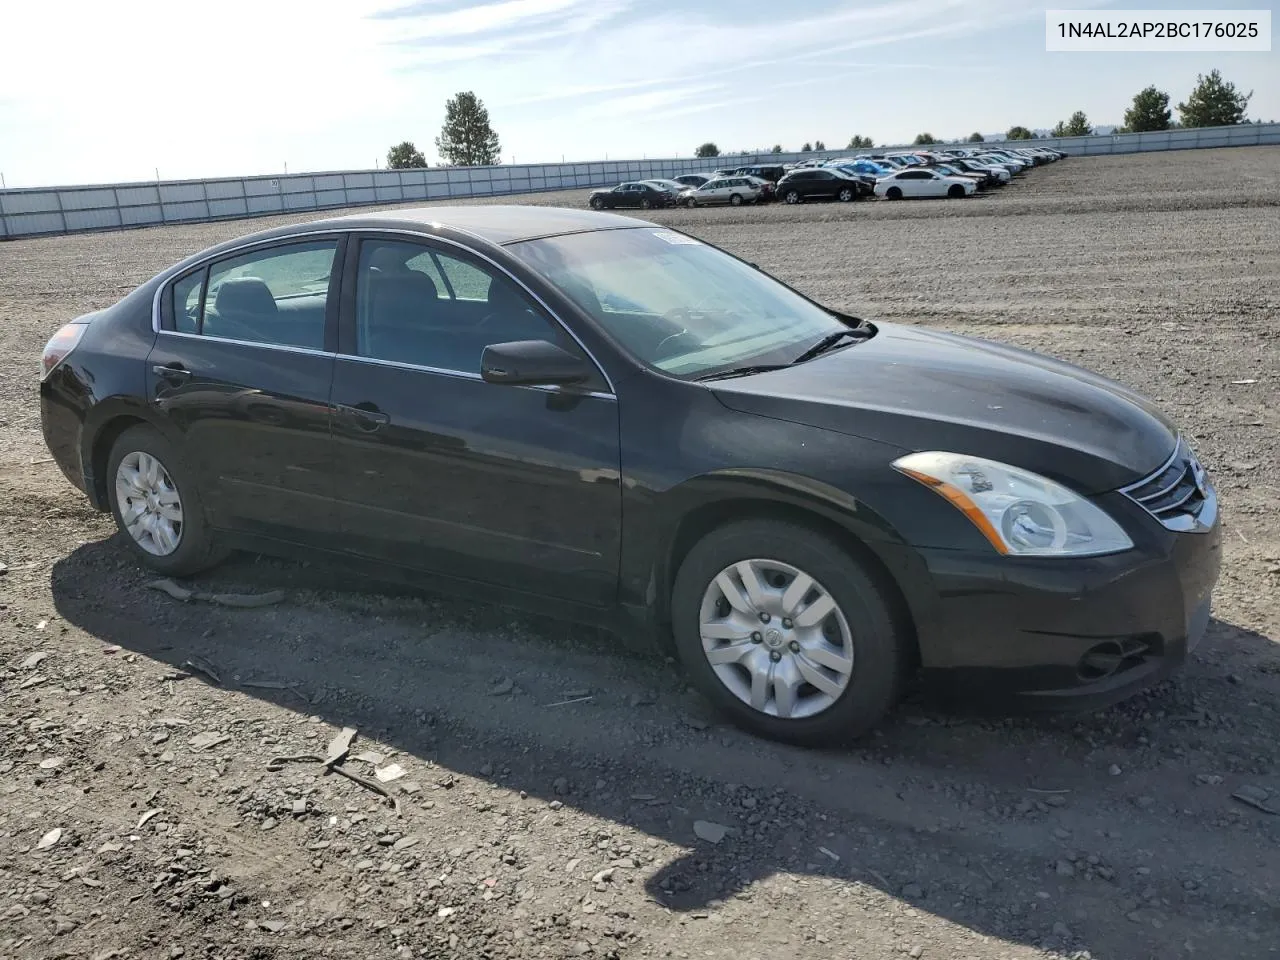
106, 425, 227, 576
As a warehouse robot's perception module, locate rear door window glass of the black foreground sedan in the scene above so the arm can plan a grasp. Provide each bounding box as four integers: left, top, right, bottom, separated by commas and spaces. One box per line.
200, 239, 338, 349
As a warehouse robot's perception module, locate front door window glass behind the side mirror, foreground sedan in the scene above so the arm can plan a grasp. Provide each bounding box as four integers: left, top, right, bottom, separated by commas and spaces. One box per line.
356, 239, 564, 375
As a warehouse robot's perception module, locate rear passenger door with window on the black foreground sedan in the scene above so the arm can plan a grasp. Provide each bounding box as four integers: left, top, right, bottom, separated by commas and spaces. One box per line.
146, 234, 344, 543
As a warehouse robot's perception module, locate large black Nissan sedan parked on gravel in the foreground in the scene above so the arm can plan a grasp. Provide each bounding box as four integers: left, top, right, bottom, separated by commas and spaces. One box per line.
40, 206, 1221, 742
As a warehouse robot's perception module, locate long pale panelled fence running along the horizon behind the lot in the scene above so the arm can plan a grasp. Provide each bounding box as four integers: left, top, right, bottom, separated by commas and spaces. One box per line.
0, 123, 1280, 239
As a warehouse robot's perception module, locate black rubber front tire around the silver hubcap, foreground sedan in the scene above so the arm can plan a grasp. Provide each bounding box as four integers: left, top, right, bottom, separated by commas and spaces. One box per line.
671, 520, 910, 746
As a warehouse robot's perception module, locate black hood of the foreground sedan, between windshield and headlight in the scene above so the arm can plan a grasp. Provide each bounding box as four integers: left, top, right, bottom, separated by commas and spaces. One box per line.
709, 324, 1176, 494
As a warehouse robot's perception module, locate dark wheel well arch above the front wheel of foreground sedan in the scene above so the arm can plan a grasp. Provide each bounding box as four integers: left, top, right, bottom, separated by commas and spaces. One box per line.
657, 498, 920, 667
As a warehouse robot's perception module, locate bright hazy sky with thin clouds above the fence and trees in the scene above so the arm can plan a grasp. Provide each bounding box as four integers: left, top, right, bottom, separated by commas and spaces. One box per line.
0, 0, 1280, 187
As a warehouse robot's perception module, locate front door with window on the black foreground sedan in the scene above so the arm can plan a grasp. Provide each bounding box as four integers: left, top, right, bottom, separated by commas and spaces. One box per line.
333, 236, 621, 605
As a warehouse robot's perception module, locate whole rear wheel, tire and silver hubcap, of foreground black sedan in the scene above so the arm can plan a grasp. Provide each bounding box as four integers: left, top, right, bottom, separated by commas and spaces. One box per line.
108, 425, 223, 576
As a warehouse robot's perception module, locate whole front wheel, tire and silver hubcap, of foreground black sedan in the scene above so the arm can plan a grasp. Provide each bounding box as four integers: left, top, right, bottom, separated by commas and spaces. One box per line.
671, 520, 909, 745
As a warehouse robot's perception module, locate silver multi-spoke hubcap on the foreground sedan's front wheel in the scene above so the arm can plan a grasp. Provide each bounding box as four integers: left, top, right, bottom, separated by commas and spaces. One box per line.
699, 559, 854, 719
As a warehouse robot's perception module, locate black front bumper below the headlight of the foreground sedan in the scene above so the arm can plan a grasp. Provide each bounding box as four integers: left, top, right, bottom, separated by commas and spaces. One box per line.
913, 488, 1222, 710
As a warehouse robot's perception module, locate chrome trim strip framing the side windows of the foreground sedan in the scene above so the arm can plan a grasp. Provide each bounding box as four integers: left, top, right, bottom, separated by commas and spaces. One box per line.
151, 227, 617, 401
